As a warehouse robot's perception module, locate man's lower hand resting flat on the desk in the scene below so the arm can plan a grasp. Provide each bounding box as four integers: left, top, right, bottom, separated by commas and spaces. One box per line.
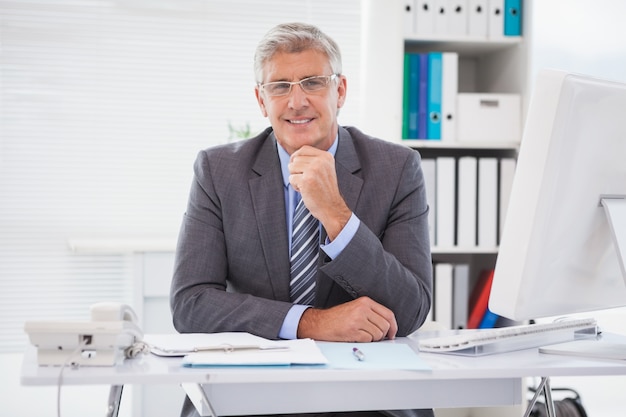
298, 297, 398, 342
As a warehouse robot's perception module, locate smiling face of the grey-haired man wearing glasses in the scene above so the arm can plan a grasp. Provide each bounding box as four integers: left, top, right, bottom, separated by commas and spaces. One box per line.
255, 50, 346, 154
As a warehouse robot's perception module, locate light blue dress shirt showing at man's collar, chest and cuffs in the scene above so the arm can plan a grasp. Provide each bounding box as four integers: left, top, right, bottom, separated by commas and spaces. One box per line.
277, 137, 361, 339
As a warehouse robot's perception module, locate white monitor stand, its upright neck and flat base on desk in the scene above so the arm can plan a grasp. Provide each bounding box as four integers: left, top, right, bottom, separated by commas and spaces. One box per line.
539, 196, 626, 360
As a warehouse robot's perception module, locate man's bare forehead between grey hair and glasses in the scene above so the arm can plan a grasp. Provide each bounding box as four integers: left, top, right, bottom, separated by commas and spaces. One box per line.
263, 49, 331, 82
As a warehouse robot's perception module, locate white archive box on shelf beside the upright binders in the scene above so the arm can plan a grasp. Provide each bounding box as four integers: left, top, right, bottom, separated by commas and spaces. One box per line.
457, 93, 522, 142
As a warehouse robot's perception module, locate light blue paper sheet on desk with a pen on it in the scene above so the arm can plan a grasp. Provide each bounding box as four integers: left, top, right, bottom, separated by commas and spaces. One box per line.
318, 341, 431, 371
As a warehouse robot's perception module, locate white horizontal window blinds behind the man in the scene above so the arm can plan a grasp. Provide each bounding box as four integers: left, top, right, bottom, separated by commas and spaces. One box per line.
0, 0, 360, 352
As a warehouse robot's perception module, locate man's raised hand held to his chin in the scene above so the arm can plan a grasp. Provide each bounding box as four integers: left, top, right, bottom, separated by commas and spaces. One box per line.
289, 146, 352, 241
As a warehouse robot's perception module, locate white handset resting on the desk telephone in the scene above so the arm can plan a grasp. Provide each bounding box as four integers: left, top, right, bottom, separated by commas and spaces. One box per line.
90, 302, 146, 358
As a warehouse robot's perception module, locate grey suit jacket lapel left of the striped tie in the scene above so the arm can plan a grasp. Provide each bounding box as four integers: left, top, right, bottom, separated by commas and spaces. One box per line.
249, 134, 290, 301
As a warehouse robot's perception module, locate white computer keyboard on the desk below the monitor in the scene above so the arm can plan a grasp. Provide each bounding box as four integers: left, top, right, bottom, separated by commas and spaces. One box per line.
418, 318, 599, 356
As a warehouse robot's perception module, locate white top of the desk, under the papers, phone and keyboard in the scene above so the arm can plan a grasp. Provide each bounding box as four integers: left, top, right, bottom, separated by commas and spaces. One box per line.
21, 332, 626, 385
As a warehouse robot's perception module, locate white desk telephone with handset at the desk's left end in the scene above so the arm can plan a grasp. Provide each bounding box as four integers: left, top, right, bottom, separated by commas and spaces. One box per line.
24, 302, 147, 366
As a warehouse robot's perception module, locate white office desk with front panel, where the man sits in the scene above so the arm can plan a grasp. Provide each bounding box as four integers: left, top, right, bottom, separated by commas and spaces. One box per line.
21, 333, 626, 415
